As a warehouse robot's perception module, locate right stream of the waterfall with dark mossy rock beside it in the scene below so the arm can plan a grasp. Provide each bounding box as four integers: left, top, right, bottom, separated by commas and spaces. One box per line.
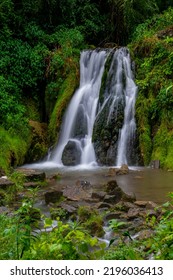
93, 48, 137, 165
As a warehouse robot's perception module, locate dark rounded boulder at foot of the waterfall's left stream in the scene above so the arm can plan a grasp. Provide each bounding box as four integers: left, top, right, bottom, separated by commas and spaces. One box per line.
62, 140, 81, 166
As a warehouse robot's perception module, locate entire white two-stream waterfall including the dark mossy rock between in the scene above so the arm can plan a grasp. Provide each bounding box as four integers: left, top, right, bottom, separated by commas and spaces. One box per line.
49, 48, 137, 166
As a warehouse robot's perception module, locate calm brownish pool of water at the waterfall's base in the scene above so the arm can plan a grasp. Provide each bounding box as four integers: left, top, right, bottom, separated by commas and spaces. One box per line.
27, 164, 173, 203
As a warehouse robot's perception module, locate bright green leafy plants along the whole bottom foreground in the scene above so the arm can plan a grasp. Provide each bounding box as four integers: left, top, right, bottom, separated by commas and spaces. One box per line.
0, 192, 173, 260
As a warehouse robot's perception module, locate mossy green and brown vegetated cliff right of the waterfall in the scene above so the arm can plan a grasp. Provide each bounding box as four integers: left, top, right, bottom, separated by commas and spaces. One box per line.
129, 8, 173, 169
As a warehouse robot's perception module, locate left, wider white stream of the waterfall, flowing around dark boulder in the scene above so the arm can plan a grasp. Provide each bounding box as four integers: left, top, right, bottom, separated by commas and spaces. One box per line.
51, 50, 107, 165
